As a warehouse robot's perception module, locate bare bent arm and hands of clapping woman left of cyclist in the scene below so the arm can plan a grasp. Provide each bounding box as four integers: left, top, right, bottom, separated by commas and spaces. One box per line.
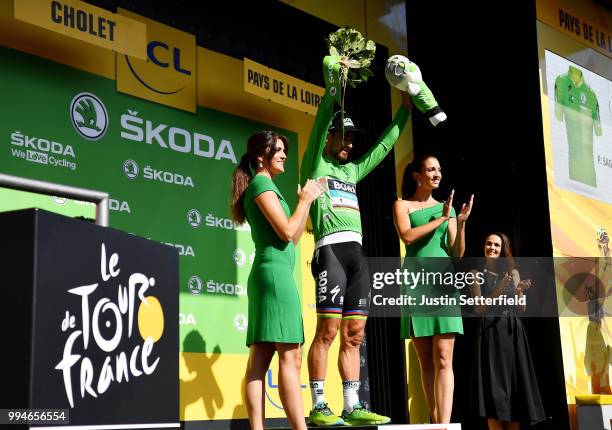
255, 180, 324, 243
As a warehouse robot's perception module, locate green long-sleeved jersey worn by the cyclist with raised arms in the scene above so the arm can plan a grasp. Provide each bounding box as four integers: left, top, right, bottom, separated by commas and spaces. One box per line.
301, 56, 409, 241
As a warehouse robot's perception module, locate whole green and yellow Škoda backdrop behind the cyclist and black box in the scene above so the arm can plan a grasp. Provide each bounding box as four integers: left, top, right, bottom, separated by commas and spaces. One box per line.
0, 0, 411, 426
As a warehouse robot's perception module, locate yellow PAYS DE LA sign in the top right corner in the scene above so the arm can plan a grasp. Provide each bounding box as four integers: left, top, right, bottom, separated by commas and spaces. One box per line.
537, 0, 612, 57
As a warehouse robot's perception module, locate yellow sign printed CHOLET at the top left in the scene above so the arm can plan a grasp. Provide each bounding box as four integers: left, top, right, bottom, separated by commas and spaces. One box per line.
14, 0, 147, 59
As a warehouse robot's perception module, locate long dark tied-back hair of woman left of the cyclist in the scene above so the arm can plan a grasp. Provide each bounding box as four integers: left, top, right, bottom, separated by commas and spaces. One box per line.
231, 130, 289, 224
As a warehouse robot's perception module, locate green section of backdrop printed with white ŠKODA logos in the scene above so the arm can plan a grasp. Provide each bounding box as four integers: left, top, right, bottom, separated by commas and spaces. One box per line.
0, 48, 300, 353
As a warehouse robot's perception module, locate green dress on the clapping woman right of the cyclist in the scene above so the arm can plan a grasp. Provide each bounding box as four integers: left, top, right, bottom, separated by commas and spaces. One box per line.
401, 203, 463, 339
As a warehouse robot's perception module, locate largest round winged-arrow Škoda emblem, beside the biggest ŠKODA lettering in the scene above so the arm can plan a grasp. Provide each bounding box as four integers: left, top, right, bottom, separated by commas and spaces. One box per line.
70, 93, 108, 140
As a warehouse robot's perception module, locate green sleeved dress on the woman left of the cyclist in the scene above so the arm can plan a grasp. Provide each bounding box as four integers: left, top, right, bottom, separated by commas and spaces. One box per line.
243, 175, 304, 346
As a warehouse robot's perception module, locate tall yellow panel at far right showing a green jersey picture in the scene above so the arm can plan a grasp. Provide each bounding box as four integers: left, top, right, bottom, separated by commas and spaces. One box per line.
537, 0, 612, 426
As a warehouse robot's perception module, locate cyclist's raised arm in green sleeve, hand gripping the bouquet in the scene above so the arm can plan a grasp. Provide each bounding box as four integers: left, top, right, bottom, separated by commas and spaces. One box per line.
300, 56, 341, 183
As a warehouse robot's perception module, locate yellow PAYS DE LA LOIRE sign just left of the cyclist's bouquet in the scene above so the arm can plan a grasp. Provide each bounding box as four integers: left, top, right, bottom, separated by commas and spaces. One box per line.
244, 58, 325, 115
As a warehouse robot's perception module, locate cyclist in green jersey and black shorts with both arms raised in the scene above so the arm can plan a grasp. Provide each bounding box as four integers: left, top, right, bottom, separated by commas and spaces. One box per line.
301, 56, 410, 425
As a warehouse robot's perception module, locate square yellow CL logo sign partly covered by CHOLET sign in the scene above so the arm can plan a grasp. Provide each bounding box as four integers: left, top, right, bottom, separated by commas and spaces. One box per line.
117, 9, 196, 112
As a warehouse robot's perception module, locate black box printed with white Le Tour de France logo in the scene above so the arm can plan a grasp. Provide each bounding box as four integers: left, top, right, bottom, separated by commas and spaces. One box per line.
0, 209, 180, 429
